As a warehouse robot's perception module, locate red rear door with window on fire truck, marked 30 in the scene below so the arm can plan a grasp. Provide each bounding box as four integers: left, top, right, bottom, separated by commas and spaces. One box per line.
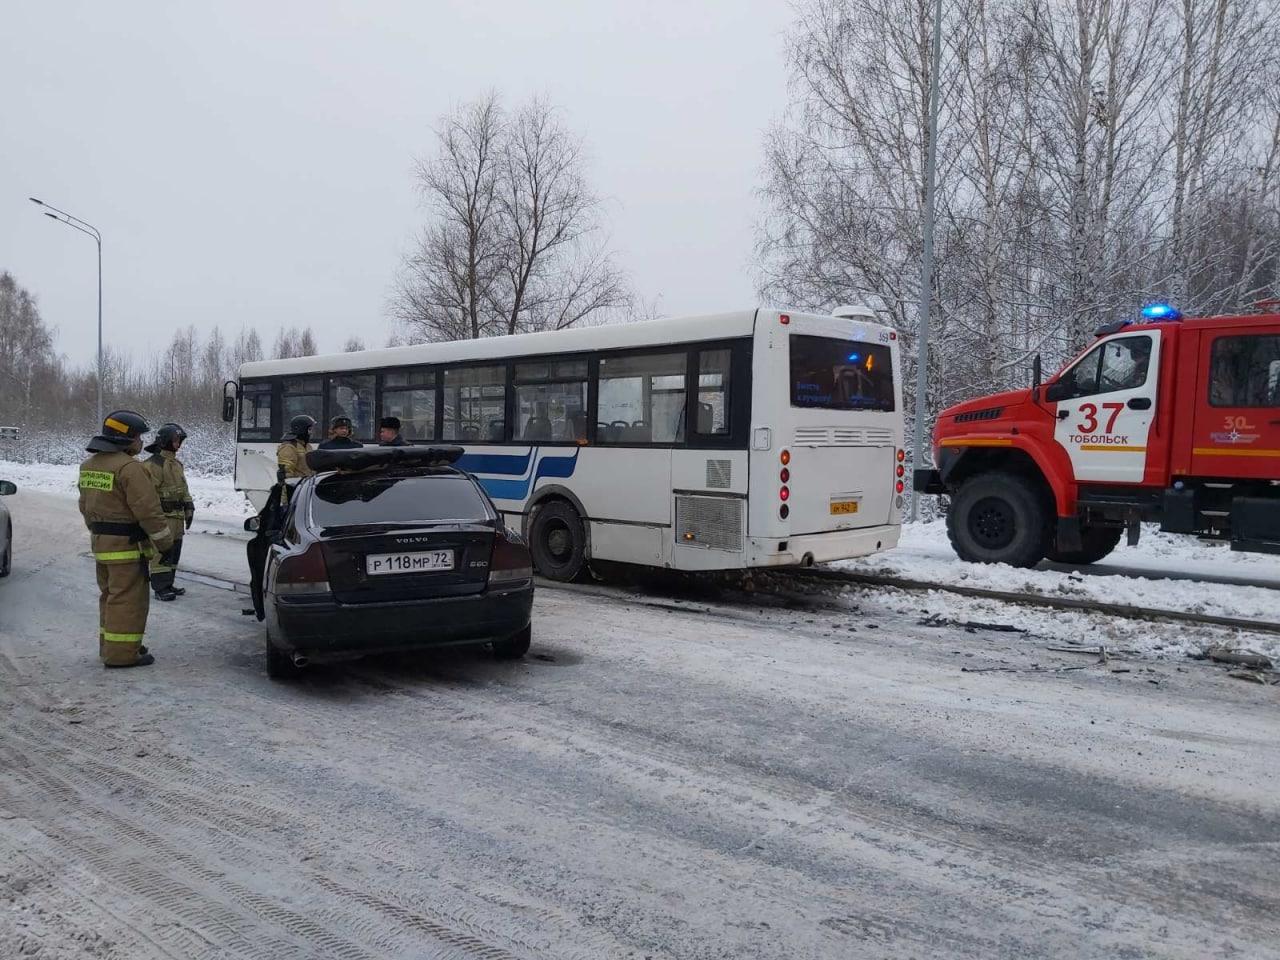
1192, 328, 1280, 480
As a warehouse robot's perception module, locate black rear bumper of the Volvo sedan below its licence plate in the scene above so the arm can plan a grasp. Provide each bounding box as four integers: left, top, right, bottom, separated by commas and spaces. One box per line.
268, 584, 534, 659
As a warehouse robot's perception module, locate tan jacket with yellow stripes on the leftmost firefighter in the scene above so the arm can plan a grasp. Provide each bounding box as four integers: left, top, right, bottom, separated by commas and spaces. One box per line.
79, 451, 174, 563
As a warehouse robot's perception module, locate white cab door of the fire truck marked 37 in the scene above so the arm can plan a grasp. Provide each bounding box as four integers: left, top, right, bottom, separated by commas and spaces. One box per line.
1053, 330, 1161, 484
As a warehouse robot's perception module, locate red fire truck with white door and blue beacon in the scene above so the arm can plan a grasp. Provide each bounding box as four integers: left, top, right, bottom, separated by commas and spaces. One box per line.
914, 302, 1280, 567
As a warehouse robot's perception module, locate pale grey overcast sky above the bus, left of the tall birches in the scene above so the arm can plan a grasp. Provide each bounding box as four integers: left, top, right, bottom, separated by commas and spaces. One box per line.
0, 0, 790, 361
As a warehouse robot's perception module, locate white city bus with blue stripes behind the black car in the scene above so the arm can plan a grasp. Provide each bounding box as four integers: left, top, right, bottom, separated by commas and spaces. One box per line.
224, 308, 904, 580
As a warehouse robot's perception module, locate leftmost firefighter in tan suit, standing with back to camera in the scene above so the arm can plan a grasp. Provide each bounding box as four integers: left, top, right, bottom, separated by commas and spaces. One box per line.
79, 410, 174, 667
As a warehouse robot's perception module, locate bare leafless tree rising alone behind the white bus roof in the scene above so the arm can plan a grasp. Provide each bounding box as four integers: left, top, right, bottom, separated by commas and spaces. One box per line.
392, 93, 628, 340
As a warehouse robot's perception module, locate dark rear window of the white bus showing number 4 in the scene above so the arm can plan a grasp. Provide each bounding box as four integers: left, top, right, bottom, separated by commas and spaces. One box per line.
791, 334, 893, 412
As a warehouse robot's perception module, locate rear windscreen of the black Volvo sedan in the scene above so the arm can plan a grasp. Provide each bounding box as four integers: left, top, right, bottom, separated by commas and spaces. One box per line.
311, 474, 489, 526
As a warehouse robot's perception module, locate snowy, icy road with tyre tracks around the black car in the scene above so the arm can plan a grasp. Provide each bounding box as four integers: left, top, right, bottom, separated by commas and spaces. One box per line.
0, 493, 1280, 960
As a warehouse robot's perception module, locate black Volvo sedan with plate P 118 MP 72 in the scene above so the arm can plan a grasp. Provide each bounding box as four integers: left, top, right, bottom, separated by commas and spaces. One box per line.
244, 447, 534, 678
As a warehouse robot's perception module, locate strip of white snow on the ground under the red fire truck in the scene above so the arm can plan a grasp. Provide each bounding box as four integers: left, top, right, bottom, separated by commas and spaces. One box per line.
833, 520, 1280, 634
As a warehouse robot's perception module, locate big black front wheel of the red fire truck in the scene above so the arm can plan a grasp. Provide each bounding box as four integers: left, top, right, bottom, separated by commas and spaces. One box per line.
947, 474, 1052, 567
